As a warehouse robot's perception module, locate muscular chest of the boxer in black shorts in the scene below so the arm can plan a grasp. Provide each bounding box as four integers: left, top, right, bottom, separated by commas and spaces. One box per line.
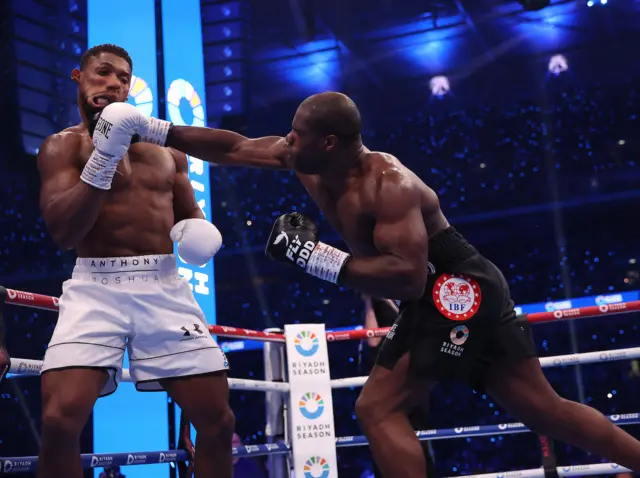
303, 176, 375, 256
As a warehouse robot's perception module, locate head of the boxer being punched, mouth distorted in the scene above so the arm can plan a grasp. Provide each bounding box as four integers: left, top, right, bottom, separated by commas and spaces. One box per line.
71, 44, 133, 122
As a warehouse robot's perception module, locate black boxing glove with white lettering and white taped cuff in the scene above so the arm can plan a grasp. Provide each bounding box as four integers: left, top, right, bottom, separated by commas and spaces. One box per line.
265, 212, 351, 284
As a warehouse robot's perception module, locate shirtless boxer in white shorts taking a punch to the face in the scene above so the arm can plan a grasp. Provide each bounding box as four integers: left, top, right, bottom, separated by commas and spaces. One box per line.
38, 45, 282, 478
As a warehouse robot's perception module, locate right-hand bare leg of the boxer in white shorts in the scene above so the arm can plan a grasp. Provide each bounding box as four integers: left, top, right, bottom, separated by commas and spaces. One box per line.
161, 371, 235, 478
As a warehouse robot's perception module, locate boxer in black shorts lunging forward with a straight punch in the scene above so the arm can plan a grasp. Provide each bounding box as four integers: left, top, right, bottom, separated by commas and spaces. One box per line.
111, 92, 640, 478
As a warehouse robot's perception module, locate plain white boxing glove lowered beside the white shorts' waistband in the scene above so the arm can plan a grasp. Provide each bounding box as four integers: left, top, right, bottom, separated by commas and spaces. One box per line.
169, 219, 222, 266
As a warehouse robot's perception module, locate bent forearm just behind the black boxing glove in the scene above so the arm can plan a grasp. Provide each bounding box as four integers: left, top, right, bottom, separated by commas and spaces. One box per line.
340, 255, 427, 300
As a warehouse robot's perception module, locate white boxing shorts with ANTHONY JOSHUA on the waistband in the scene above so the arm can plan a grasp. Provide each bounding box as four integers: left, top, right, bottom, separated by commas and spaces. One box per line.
42, 255, 229, 396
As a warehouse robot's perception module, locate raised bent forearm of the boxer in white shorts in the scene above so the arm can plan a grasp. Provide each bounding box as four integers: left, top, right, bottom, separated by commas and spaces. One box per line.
42, 181, 108, 250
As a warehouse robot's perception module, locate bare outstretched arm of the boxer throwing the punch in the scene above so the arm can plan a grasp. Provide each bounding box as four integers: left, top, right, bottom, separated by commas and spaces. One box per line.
166, 126, 287, 169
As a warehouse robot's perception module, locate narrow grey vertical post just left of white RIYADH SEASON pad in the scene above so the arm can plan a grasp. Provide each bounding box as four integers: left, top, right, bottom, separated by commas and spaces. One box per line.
263, 328, 290, 478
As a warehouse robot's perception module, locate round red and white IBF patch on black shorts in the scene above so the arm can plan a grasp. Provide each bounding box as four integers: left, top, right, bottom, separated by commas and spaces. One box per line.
433, 274, 482, 320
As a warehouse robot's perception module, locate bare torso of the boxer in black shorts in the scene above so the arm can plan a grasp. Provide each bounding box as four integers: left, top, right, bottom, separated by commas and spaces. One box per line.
296, 152, 449, 257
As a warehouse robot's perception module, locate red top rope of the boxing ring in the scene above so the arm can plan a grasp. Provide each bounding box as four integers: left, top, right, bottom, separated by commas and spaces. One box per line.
5, 289, 640, 342
